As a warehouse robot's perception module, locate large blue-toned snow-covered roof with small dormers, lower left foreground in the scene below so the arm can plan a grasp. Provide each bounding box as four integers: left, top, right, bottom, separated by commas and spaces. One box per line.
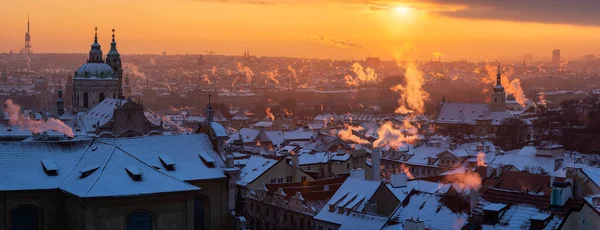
0, 134, 225, 197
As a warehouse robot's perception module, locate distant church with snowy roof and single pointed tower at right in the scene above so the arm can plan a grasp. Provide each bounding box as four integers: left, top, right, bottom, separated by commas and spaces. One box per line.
434, 66, 514, 137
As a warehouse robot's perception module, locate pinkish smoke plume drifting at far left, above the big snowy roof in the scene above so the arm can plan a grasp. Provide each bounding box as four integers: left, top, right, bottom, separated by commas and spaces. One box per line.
4, 99, 74, 137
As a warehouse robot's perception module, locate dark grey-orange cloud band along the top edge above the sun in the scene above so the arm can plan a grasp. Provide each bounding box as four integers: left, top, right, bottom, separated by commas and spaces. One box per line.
195, 0, 600, 26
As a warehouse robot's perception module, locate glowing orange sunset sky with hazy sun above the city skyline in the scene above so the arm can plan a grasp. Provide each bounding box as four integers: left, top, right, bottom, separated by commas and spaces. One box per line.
0, 0, 600, 61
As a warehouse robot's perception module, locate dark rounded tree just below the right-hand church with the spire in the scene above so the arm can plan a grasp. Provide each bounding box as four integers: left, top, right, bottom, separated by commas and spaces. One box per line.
495, 117, 527, 150
